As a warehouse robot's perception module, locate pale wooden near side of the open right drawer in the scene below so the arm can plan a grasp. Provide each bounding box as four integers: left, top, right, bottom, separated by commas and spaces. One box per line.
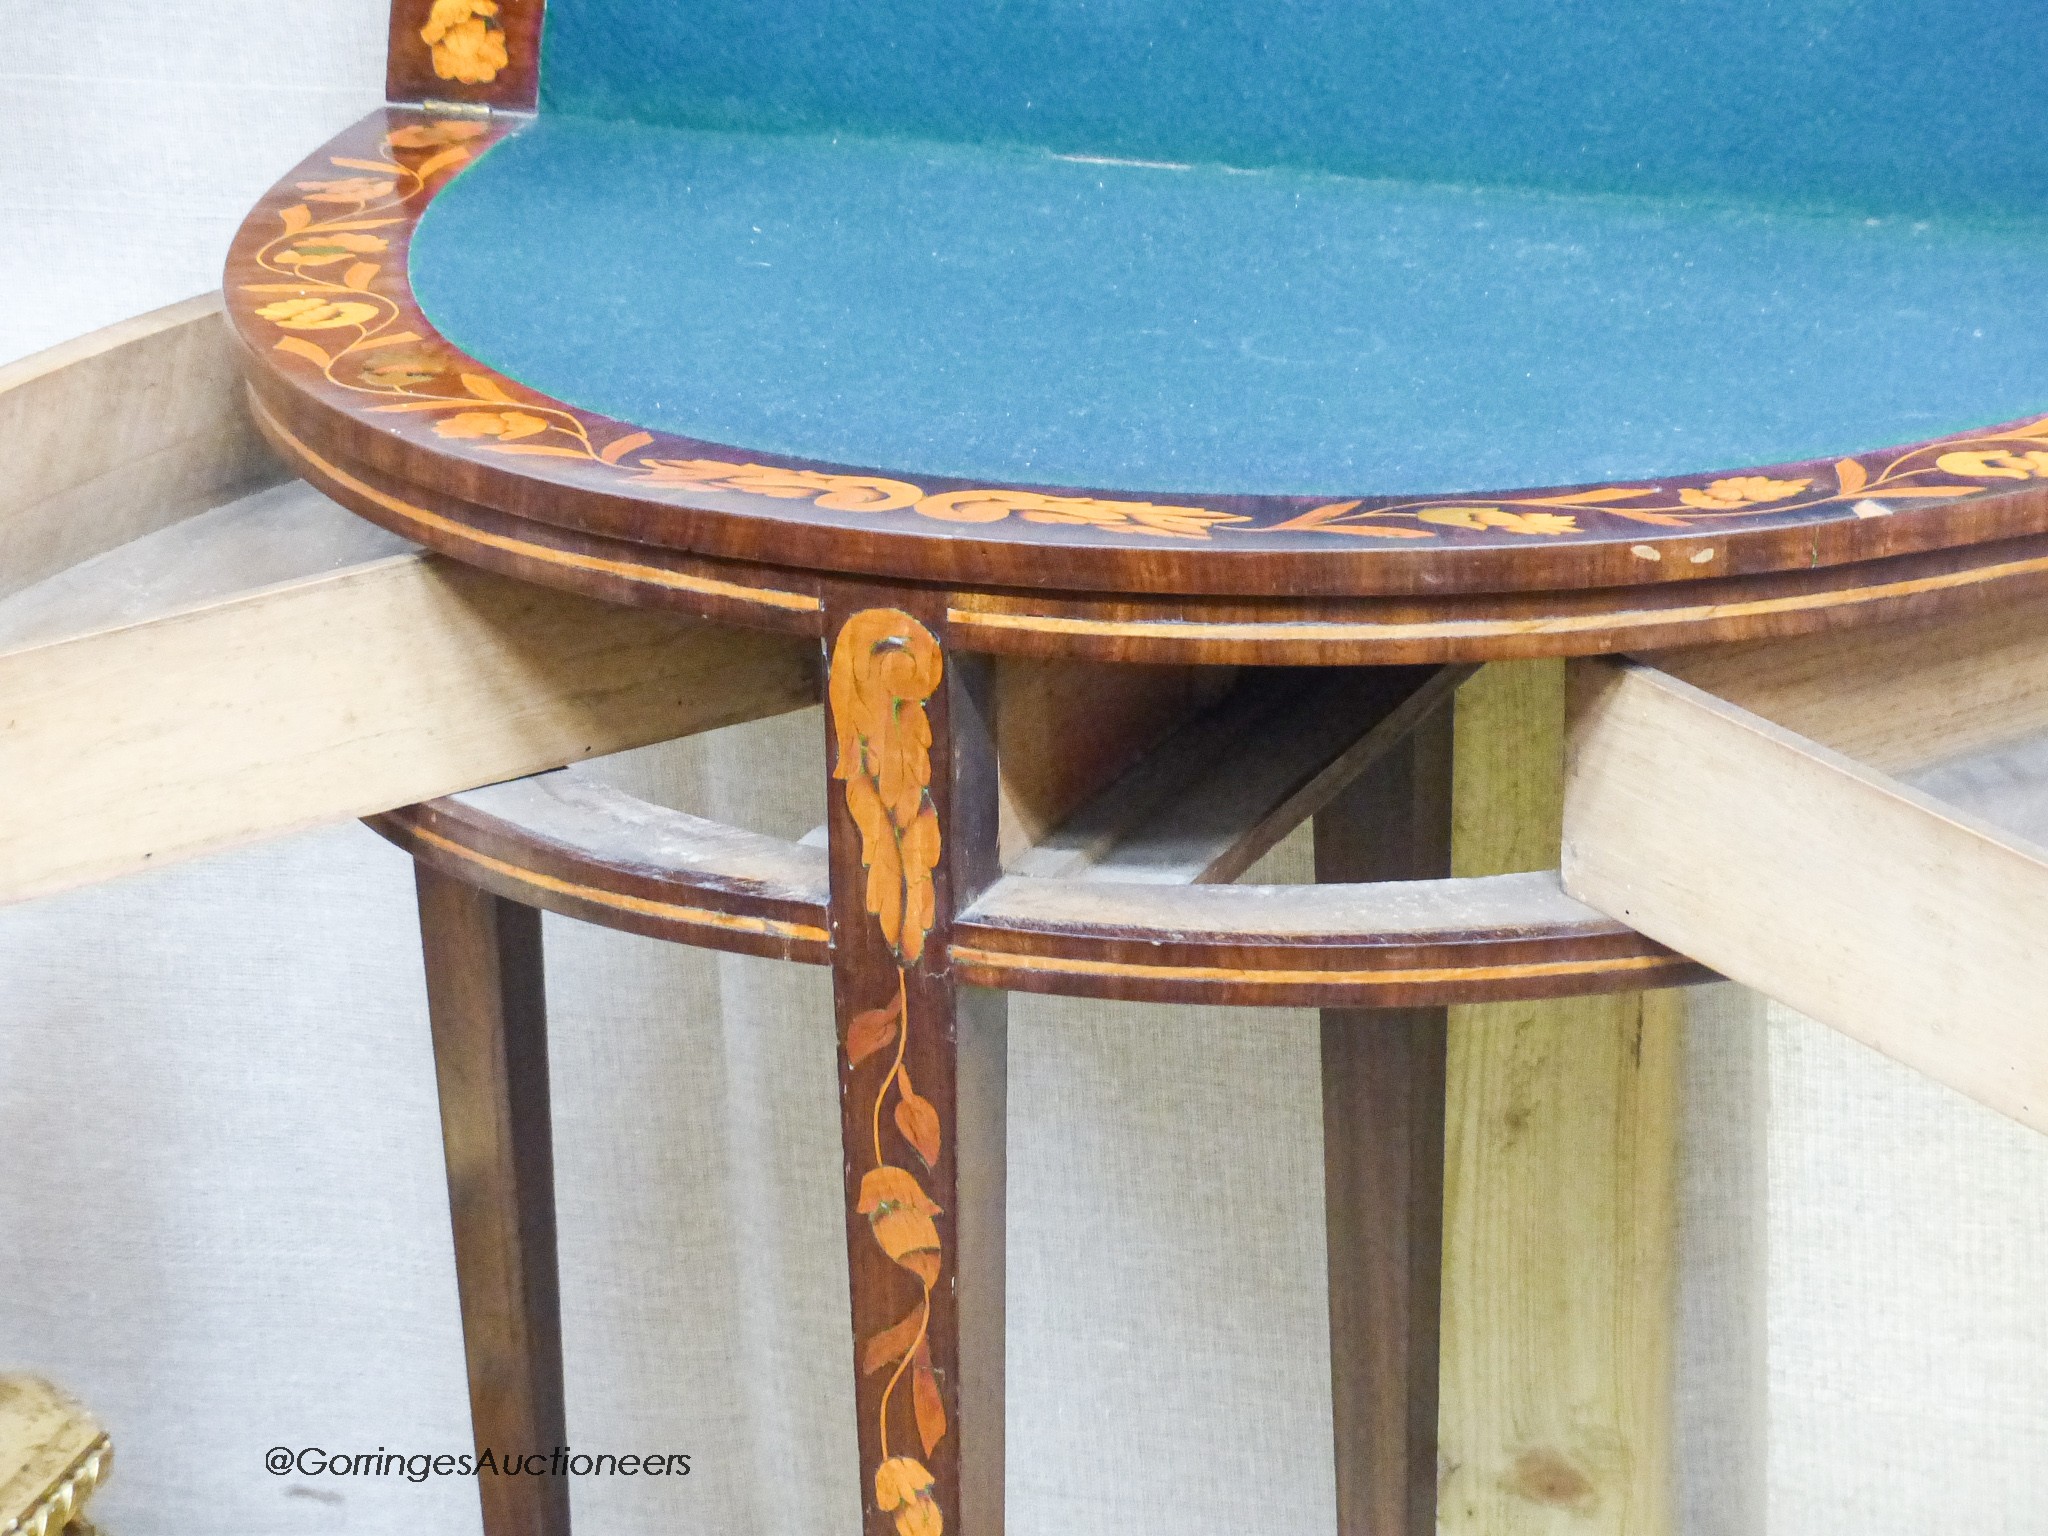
1563, 662, 2048, 1130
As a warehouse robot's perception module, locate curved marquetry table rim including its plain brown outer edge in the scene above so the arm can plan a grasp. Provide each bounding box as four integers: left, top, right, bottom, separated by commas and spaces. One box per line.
227, 105, 2048, 618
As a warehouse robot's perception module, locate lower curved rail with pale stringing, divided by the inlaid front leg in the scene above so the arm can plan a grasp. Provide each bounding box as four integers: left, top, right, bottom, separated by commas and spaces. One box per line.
371, 772, 1708, 1008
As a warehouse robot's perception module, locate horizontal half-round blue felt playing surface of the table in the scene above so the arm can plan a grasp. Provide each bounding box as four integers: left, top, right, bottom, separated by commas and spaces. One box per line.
412, 117, 2048, 494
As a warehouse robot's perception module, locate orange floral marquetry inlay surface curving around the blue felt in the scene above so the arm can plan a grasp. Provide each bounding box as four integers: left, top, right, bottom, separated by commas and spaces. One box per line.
238, 111, 2048, 573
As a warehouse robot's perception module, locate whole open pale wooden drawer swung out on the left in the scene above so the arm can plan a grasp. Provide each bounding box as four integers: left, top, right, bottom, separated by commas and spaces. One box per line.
0, 305, 817, 901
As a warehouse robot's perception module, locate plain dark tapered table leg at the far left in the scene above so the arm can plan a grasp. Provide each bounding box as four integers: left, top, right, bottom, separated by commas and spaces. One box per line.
416, 864, 569, 1536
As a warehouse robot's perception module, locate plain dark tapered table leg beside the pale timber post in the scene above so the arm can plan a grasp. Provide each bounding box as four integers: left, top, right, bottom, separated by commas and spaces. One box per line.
1315, 705, 1452, 1536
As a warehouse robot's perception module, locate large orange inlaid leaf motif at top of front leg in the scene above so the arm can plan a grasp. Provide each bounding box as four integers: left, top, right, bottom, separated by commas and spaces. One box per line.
829, 608, 944, 965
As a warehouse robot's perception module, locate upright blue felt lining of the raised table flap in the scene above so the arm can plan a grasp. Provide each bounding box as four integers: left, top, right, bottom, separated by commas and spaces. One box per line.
541, 0, 2048, 215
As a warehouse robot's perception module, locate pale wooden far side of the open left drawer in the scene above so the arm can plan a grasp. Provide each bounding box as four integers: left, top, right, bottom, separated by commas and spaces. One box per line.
0, 293, 287, 598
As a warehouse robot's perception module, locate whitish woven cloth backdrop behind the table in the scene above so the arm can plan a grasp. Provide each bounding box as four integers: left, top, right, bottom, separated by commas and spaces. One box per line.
0, 0, 2048, 1536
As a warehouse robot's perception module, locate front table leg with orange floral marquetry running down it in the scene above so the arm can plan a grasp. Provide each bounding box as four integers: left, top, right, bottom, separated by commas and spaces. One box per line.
827, 590, 1008, 1536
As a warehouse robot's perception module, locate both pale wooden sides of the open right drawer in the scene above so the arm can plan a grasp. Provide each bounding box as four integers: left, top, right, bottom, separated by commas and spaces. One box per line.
1563, 602, 2048, 1130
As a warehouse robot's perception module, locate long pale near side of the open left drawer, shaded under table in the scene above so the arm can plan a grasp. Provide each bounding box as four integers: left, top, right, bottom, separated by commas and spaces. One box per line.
0, 555, 817, 901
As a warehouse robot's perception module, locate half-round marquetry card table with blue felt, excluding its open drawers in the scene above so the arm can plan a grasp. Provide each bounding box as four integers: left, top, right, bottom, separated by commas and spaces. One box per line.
225, 0, 2048, 1536
